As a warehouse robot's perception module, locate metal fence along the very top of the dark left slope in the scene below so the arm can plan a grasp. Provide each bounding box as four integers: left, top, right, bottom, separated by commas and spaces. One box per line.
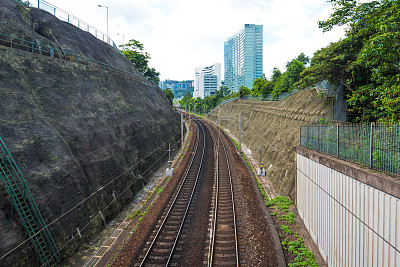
27, 0, 121, 53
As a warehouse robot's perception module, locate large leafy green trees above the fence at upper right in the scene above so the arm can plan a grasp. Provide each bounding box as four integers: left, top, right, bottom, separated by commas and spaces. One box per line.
297, 0, 400, 123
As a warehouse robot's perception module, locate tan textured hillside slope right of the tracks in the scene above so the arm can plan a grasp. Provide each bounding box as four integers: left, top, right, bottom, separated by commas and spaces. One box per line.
208, 89, 332, 198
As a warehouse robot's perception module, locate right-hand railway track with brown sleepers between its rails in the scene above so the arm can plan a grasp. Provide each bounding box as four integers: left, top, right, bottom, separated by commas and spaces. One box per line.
207, 122, 239, 266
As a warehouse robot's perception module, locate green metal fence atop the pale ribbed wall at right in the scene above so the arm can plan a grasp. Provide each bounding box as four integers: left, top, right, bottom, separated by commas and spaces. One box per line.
300, 124, 400, 178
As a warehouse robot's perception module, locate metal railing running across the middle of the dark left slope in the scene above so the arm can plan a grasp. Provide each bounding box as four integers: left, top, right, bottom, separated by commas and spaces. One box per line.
0, 33, 150, 82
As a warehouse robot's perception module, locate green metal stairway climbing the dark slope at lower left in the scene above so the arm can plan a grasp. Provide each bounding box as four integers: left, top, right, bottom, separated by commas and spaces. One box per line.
0, 137, 61, 266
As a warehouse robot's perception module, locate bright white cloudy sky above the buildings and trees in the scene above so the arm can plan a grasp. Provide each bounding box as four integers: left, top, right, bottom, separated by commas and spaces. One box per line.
30, 0, 344, 80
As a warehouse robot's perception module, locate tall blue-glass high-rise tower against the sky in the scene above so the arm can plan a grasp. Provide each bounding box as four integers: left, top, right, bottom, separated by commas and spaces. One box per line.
224, 24, 263, 92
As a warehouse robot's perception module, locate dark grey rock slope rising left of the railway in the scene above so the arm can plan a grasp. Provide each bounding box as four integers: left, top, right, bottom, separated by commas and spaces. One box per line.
0, 0, 180, 266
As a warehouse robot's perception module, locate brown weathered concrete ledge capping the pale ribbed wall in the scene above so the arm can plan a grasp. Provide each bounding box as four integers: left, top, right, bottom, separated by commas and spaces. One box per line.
296, 146, 400, 198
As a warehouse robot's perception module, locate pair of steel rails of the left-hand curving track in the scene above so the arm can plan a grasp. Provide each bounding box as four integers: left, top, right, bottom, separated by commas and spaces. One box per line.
140, 120, 206, 266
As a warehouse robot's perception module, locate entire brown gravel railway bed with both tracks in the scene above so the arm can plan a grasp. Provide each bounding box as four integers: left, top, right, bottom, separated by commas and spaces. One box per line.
113, 114, 285, 267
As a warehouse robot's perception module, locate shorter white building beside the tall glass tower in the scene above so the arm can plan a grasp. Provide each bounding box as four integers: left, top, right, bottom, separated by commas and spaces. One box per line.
193, 63, 221, 98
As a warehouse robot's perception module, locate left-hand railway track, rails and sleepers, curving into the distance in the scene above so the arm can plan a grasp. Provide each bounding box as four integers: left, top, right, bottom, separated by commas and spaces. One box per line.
135, 121, 206, 266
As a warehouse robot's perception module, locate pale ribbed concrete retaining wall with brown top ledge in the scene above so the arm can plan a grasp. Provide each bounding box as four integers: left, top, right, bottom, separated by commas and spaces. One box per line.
296, 148, 400, 267
